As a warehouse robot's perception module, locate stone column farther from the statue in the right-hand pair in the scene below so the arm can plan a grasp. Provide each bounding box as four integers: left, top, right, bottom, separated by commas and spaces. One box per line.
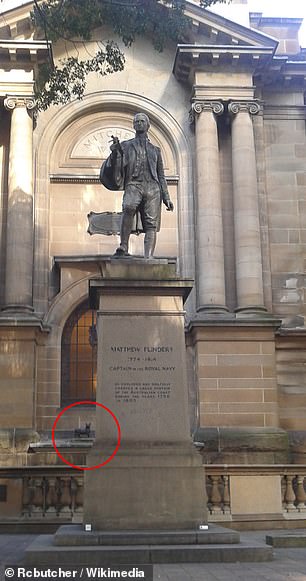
229, 101, 266, 313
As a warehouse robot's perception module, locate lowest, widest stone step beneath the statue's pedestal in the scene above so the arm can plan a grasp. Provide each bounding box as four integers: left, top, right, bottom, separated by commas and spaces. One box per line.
25, 535, 273, 567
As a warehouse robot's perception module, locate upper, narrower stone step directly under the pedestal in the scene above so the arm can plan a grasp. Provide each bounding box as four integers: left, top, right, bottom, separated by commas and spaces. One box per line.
54, 524, 240, 547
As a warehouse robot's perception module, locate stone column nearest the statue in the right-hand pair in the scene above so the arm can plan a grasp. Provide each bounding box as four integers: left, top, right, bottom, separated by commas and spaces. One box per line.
192, 101, 227, 314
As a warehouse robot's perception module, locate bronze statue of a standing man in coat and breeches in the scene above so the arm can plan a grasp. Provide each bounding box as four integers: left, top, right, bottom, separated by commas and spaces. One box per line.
100, 113, 173, 258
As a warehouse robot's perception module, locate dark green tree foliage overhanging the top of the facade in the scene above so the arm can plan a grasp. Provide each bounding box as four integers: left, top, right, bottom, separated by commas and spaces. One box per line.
32, 0, 230, 110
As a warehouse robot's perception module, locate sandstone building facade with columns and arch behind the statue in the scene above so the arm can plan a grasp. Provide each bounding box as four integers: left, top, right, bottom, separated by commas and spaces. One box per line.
0, 2, 306, 524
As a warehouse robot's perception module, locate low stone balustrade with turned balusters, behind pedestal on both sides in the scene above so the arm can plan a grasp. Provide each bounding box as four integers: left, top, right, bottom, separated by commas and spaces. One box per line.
0, 464, 306, 523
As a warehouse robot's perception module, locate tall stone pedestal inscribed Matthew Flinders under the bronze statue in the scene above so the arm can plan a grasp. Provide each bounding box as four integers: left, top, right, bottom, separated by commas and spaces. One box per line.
84, 259, 206, 530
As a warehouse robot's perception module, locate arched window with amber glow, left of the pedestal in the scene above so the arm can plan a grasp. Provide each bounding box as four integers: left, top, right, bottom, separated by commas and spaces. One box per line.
61, 301, 97, 405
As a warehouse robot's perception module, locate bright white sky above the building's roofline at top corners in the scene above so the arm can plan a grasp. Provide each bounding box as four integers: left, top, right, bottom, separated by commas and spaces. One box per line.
0, 0, 306, 48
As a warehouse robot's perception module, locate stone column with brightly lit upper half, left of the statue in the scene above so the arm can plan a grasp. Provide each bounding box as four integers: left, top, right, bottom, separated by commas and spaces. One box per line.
4, 96, 35, 312
